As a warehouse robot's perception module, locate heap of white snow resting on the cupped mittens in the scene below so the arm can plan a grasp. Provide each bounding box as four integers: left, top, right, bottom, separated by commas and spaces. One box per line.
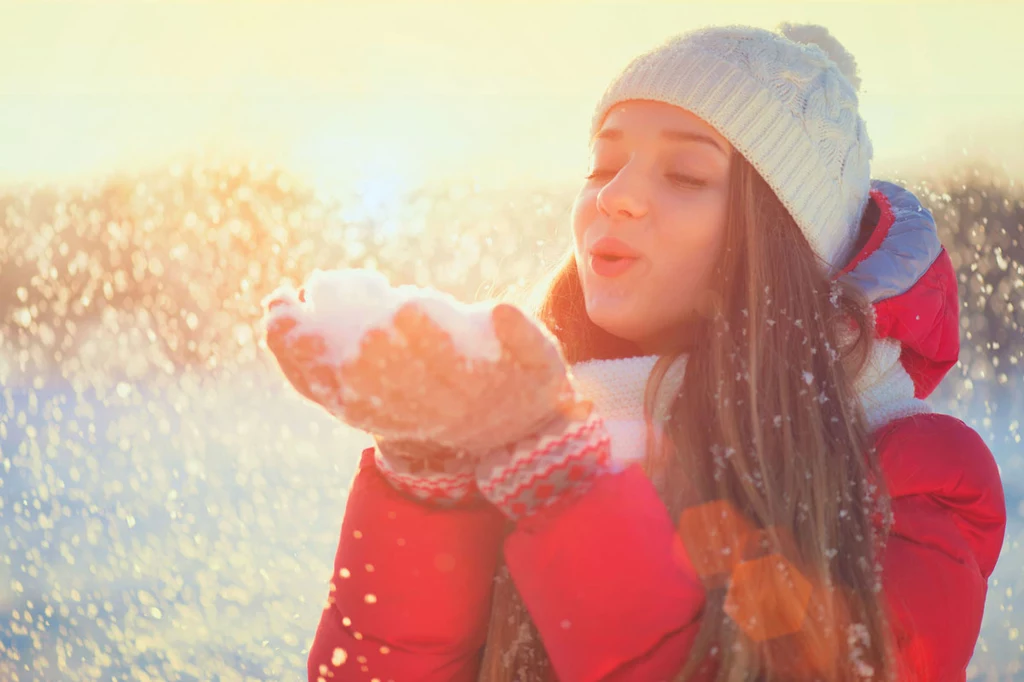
263, 268, 501, 365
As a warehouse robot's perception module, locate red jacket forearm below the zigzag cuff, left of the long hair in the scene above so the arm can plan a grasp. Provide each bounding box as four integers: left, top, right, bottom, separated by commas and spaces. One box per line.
505, 465, 703, 682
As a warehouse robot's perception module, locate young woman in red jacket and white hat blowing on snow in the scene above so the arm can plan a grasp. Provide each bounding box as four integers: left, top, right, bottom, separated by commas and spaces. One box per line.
267, 21, 1006, 682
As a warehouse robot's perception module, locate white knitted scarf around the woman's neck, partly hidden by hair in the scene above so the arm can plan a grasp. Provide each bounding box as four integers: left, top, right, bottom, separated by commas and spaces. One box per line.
569, 339, 931, 464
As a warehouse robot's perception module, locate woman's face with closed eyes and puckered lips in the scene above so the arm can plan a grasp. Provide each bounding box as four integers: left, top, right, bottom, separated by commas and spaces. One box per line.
572, 100, 732, 353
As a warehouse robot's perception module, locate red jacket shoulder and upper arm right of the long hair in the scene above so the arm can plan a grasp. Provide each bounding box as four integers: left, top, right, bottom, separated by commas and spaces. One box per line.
877, 415, 1007, 682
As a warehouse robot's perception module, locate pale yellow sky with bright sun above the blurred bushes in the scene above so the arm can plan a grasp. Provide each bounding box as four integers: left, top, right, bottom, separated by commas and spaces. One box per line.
0, 0, 1024, 201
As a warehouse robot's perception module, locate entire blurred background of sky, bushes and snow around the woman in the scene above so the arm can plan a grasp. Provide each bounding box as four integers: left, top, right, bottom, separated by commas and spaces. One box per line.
0, 0, 1024, 681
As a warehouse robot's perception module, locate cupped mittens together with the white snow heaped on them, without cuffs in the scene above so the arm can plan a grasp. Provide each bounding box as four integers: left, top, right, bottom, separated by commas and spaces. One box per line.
264, 270, 589, 501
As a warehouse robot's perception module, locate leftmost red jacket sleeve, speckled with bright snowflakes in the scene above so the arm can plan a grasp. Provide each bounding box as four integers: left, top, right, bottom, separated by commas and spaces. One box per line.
307, 447, 505, 682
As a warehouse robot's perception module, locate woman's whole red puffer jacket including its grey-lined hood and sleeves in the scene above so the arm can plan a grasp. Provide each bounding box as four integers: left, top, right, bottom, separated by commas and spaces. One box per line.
308, 181, 1006, 682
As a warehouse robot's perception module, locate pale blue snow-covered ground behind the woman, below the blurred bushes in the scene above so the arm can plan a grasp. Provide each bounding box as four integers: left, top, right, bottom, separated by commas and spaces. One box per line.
0, 360, 1024, 681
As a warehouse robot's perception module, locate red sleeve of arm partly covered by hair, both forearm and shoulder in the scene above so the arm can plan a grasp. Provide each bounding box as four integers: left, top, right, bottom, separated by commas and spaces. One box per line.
505, 415, 1006, 682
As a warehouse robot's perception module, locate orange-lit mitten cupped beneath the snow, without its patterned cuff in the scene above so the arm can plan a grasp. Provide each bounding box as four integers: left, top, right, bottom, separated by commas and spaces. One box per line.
266, 278, 575, 453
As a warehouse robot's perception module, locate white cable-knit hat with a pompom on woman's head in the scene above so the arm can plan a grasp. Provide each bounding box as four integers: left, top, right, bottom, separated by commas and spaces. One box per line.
591, 24, 872, 270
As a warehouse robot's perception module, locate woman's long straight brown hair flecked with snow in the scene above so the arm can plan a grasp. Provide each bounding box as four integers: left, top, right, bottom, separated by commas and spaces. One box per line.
480, 153, 894, 682
